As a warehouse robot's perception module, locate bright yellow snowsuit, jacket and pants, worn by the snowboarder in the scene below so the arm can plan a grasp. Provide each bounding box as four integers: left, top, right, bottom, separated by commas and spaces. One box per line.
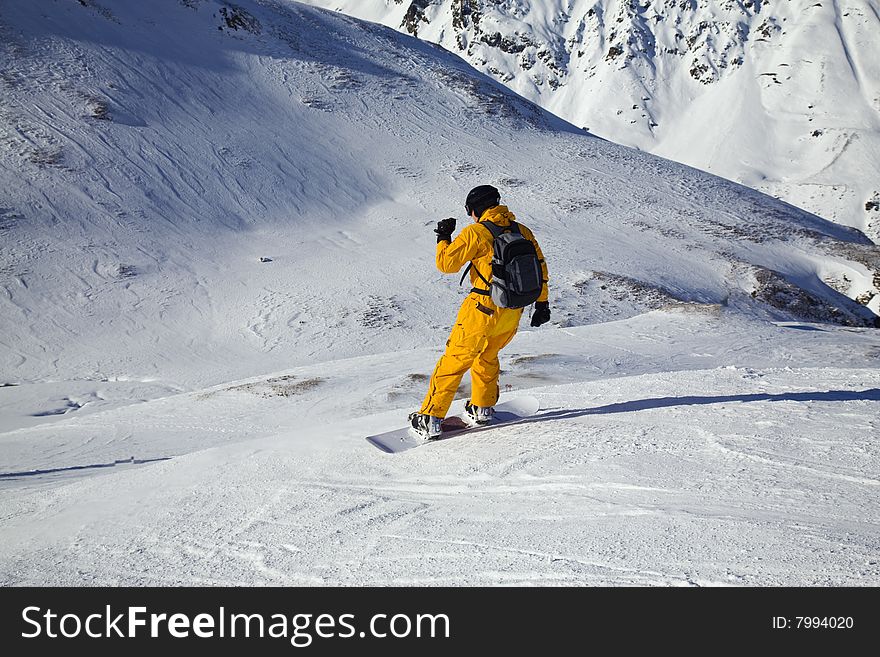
419, 205, 547, 418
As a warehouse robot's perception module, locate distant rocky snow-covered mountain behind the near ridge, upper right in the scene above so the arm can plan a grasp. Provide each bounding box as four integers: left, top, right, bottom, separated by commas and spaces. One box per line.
298, 0, 880, 242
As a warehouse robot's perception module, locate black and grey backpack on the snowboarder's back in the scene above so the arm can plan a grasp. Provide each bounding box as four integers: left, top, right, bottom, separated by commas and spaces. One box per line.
461, 221, 544, 308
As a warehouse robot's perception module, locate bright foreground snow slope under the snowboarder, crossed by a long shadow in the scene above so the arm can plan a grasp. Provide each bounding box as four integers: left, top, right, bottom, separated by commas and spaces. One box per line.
0, 311, 880, 586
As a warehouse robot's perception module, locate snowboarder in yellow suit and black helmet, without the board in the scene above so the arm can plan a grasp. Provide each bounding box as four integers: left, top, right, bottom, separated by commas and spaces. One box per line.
409, 185, 550, 439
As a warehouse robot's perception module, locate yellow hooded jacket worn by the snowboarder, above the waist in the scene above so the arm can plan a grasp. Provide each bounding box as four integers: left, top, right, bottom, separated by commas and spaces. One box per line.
437, 205, 548, 303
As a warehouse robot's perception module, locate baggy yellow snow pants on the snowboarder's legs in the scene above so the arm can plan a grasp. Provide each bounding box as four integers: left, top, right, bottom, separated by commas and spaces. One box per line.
419, 292, 523, 418
